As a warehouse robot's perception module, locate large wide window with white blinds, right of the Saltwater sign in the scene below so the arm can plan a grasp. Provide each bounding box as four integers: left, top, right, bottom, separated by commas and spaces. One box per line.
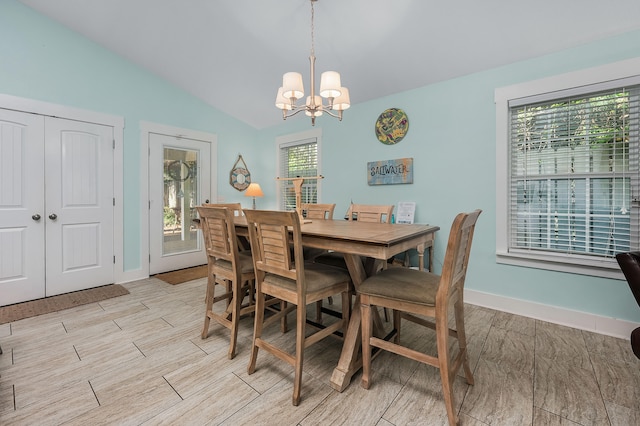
507, 85, 640, 264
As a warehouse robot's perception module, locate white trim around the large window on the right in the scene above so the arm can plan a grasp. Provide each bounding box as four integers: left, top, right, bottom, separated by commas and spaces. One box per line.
494, 58, 640, 279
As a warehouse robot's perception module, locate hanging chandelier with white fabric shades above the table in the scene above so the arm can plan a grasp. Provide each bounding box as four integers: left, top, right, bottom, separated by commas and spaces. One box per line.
276, 0, 351, 126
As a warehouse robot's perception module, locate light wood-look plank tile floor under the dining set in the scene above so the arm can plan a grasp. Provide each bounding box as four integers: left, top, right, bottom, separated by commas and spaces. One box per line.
0, 278, 640, 426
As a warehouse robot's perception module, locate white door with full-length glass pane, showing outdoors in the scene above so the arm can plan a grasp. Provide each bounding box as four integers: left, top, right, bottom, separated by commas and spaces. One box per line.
149, 133, 211, 275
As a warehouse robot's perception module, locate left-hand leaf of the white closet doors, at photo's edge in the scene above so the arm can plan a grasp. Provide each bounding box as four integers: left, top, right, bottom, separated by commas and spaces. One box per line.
0, 109, 45, 306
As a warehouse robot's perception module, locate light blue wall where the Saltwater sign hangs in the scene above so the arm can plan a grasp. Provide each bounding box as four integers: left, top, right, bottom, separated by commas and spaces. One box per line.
260, 32, 640, 322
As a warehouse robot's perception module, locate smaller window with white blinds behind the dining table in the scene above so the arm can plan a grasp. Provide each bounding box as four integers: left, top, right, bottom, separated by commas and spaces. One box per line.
279, 137, 319, 210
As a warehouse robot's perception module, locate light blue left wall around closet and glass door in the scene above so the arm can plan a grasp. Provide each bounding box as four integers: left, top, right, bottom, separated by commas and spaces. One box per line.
0, 0, 257, 271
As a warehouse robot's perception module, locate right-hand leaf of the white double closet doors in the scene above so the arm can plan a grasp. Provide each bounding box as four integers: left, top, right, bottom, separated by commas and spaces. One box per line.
43, 117, 114, 296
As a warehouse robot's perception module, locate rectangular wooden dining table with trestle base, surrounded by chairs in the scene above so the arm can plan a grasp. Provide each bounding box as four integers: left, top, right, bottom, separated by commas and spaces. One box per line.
236, 216, 440, 392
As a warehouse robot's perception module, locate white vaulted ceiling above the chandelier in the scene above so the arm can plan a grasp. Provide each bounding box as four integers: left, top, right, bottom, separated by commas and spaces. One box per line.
21, 0, 640, 129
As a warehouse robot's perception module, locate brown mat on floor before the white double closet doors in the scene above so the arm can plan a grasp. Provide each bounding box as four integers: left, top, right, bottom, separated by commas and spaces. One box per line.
0, 284, 129, 324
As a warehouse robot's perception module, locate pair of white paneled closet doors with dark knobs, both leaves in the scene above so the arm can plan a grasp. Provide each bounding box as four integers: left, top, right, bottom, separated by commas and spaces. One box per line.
0, 109, 114, 306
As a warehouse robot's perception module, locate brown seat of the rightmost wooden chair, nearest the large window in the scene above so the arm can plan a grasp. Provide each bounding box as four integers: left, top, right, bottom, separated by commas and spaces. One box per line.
358, 268, 440, 306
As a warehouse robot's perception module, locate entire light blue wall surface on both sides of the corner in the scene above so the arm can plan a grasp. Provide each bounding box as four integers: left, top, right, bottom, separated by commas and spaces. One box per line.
0, 0, 640, 322
